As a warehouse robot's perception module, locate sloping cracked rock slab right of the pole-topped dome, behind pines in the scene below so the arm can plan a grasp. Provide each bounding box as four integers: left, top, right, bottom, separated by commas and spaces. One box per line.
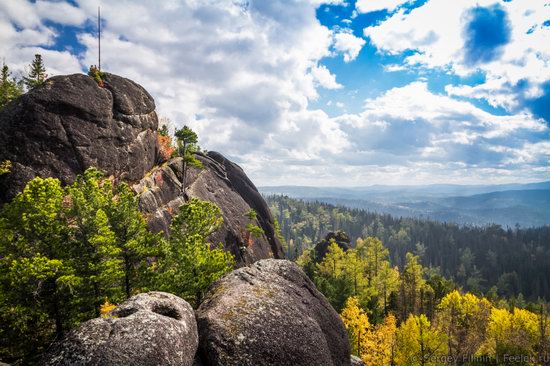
134, 152, 284, 264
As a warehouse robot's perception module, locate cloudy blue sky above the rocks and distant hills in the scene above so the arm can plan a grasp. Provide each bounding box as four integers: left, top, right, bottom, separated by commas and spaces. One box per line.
0, 0, 550, 186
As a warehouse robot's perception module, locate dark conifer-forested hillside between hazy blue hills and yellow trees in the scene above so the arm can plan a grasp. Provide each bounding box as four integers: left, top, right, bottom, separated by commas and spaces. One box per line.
267, 196, 550, 300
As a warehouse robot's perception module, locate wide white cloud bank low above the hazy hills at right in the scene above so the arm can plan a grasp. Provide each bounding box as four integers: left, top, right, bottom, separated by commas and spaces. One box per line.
324, 82, 549, 182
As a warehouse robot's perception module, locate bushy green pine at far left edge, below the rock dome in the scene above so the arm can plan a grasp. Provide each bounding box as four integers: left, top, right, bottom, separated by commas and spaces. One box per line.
0, 178, 78, 362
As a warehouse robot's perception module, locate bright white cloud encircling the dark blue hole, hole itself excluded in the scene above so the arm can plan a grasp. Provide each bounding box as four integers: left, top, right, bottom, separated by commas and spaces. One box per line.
364, 0, 550, 110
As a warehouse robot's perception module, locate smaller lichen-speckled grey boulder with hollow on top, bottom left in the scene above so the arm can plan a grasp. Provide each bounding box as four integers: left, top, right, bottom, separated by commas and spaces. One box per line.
41, 292, 198, 366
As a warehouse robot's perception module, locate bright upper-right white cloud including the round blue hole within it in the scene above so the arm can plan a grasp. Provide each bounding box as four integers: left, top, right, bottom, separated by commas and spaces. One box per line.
364, 0, 550, 122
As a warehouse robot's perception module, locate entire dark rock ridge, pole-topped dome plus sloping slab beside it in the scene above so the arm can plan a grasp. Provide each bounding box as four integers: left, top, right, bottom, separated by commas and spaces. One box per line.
0, 74, 284, 264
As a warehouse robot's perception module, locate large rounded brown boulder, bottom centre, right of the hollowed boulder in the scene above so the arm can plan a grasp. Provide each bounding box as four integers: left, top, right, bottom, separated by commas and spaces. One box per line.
197, 259, 350, 366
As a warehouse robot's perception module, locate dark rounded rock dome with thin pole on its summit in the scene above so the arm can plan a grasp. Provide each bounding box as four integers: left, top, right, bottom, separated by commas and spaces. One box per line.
0, 74, 158, 204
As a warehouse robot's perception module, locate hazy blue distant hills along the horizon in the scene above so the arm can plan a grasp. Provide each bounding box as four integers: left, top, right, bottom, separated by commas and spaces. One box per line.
259, 182, 550, 227
